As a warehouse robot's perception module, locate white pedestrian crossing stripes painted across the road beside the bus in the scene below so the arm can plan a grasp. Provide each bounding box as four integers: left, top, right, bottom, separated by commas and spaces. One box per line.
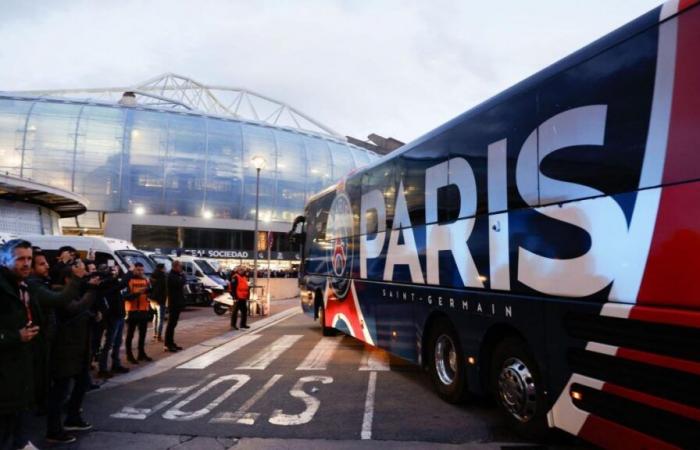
177, 333, 391, 371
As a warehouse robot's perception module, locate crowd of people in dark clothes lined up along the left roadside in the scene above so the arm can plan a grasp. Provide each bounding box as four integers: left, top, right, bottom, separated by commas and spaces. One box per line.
0, 239, 191, 450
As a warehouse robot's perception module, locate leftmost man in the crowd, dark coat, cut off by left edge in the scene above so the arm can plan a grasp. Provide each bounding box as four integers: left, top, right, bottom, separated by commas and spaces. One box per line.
0, 239, 42, 449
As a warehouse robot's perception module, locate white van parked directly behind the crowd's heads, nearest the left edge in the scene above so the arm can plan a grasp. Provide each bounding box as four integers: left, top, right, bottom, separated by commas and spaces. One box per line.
19, 234, 155, 275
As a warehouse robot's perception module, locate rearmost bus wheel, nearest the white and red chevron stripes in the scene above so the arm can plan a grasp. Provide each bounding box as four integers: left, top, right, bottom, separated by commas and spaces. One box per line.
490, 337, 548, 439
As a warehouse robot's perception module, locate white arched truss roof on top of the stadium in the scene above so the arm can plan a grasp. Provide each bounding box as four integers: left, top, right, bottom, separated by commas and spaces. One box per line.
8, 73, 345, 140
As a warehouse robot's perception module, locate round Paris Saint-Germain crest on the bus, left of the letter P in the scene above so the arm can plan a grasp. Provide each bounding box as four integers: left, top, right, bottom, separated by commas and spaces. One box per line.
326, 191, 353, 300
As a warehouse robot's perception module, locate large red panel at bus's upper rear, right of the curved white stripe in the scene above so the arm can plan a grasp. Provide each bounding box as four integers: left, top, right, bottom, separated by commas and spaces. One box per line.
637, 6, 700, 309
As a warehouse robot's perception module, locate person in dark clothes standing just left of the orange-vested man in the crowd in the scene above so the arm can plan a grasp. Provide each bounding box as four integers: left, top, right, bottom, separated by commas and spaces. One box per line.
97, 265, 129, 379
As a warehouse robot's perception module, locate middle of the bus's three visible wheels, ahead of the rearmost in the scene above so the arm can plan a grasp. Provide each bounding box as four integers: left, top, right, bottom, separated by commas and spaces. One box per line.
428, 319, 468, 403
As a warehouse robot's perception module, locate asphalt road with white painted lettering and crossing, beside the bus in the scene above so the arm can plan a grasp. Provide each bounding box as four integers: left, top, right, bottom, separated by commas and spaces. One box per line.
26, 308, 584, 448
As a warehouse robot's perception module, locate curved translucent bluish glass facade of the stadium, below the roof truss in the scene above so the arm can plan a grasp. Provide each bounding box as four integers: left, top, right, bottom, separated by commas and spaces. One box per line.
0, 95, 377, 222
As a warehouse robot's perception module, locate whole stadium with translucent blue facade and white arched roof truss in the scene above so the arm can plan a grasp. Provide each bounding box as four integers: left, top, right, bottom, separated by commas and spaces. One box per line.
0, 74, 377, 258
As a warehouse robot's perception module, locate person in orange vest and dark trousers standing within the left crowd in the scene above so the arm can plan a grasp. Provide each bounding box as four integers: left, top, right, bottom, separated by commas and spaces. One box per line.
124, 262, 153, 364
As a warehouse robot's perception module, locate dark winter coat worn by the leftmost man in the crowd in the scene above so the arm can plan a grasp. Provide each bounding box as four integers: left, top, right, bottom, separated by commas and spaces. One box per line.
0, 267, 46, 414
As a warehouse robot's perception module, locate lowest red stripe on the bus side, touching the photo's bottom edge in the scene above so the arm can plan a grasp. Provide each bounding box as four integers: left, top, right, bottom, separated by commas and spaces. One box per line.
578, 414, 679, 450
